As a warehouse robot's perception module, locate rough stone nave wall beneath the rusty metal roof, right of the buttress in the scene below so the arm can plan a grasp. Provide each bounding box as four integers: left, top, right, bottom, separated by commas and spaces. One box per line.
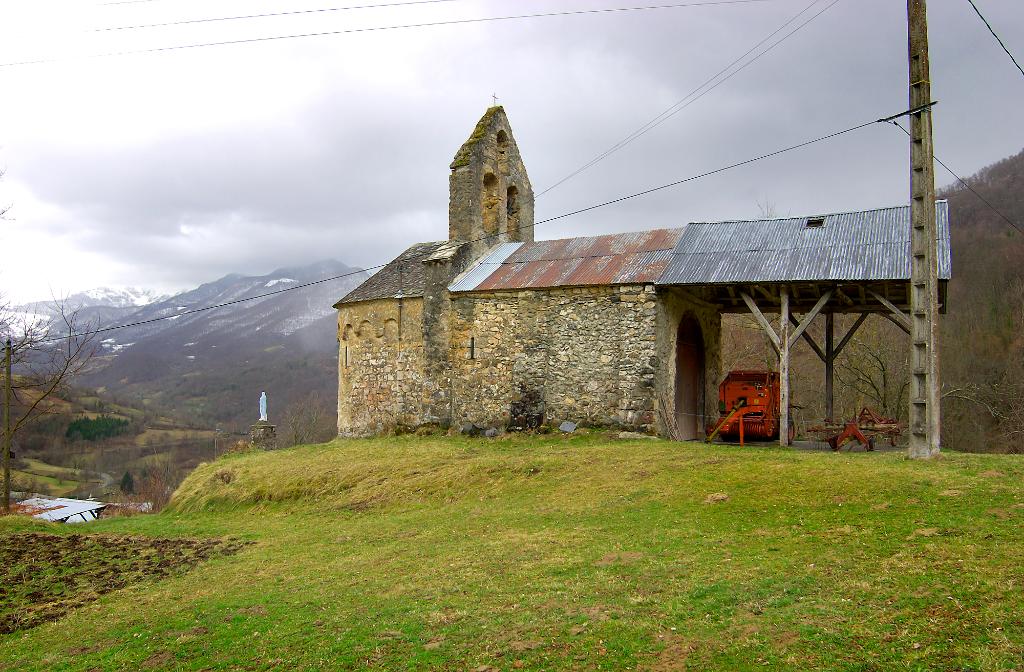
451, 285, 658, 431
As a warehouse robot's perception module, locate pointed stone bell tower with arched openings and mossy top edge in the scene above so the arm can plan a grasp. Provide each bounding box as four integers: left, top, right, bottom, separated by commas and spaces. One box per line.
449, 106, 534, 259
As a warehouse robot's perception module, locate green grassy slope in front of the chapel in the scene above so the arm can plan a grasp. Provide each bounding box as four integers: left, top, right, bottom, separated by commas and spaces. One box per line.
0, 433, 1024, 670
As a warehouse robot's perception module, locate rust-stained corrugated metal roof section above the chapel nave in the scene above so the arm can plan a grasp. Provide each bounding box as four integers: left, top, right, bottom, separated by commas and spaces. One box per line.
449, 228, 682, 292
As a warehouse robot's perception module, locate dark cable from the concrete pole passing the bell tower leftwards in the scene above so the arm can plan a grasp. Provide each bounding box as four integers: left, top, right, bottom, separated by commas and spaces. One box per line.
40, 103, 921, 343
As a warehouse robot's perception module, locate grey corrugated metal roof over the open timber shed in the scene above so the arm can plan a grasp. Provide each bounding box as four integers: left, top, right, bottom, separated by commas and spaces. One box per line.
657, 201, 950, 285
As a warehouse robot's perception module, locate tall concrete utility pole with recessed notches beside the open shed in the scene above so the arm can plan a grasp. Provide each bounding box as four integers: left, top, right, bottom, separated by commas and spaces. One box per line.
906, 0, 941, 459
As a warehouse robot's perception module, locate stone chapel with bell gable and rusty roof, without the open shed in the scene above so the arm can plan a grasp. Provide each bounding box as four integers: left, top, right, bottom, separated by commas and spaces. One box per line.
335, 107, 721, 438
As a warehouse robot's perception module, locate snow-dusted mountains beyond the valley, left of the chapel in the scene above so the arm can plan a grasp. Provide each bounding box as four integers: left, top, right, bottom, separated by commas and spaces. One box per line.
15, 260, 367, 430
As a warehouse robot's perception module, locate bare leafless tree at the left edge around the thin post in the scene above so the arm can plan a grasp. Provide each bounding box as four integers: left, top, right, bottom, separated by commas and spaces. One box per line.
0, 300, 96, 511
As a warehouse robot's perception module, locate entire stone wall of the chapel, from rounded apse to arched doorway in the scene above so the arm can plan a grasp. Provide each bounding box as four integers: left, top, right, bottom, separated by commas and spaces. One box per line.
338, 285, 722, 436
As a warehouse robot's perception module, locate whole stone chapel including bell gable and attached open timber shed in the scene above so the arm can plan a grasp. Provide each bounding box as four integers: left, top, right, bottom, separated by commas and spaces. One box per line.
335, 107, 950, 440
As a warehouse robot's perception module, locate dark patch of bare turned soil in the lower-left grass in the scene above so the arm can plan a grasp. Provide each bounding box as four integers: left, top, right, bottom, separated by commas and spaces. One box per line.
0, 533, 246, 634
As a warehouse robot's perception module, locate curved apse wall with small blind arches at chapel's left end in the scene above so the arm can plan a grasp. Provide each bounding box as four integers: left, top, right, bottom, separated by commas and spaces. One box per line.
338, 298, 424, 435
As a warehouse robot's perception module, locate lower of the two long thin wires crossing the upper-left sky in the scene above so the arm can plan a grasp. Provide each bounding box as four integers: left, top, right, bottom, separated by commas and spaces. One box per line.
0, 0, 774, 68
